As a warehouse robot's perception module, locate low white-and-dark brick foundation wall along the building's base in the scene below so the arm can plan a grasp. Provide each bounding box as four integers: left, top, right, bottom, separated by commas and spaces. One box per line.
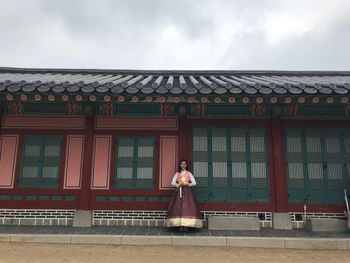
0, 209, 346, 228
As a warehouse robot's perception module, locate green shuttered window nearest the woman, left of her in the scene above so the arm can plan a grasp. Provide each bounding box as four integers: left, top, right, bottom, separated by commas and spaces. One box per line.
115, 136, 155, 189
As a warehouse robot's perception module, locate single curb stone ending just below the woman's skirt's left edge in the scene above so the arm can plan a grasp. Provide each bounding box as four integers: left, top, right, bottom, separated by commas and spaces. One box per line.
122, 235, 171, 246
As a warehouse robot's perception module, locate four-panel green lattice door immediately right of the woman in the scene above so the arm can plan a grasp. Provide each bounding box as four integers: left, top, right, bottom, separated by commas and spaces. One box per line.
192, 127, 269, 202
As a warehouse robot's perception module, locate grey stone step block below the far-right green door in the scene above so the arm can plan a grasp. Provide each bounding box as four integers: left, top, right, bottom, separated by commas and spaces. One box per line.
306, 218, 348, 232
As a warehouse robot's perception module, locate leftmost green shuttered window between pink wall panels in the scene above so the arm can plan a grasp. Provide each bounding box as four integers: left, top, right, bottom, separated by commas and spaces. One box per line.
20, 135, 62, 188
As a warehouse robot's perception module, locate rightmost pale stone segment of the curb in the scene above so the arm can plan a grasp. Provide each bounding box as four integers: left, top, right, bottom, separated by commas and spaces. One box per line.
284, 238, 348, 249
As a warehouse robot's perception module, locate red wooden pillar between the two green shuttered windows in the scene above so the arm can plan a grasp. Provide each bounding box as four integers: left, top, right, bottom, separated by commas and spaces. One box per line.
79, 116, 95, 210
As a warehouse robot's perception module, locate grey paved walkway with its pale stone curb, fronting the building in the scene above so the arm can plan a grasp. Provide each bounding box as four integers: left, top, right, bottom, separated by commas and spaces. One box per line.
0, 226, 350, 250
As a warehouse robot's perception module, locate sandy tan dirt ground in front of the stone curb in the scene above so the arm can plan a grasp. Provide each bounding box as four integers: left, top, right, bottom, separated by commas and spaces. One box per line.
0, 243, 350, 263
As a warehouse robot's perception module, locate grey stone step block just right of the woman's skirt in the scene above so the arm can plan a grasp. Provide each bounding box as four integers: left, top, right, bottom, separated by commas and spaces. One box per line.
208, 216, 260, 230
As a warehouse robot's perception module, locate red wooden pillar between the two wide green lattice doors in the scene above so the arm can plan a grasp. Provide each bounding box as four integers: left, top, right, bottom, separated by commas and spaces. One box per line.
271, 118, 288, 212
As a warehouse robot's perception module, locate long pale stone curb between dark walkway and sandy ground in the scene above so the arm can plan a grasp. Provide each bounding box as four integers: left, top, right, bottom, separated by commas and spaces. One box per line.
0, 236, 350, 250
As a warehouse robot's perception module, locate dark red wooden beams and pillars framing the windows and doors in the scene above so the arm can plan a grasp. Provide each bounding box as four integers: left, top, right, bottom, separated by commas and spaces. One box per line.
0, 116, 350, 212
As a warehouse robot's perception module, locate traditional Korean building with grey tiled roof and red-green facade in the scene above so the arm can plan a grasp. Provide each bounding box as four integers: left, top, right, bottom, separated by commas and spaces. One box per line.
0, 68, 350, 227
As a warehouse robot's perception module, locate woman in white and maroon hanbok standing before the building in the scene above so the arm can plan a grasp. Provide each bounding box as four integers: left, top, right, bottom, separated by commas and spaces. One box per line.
166, 160, 203, 229
